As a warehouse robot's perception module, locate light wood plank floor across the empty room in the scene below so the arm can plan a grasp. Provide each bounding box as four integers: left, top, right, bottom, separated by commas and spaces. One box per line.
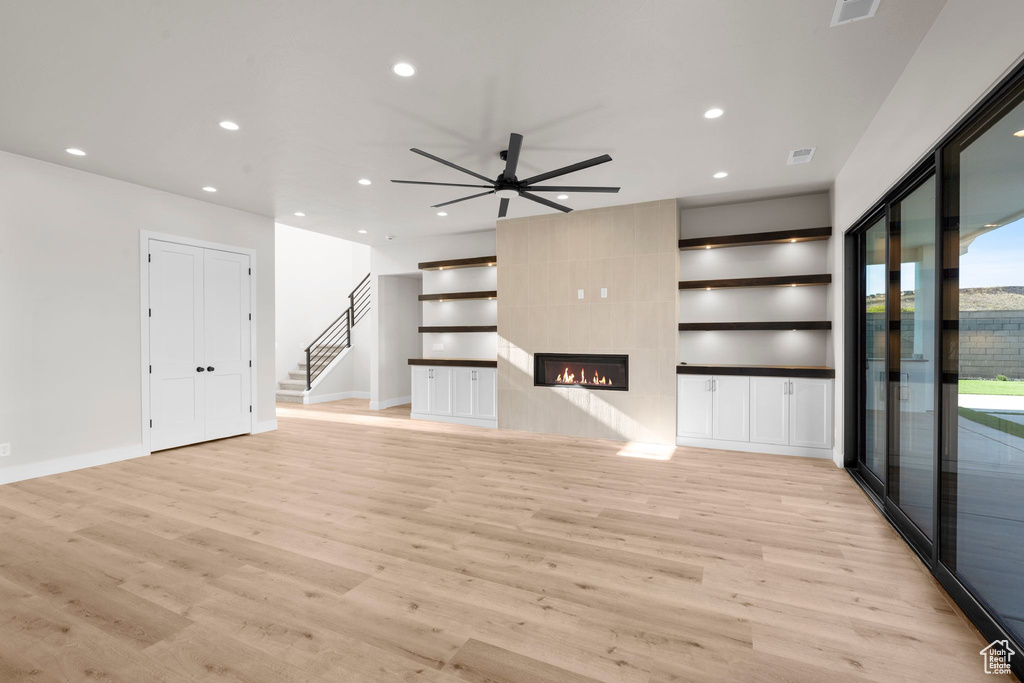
0, 400, 1003, 683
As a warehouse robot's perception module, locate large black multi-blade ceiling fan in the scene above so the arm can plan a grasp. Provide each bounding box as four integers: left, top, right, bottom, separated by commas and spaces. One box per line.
391, 133, 618, 218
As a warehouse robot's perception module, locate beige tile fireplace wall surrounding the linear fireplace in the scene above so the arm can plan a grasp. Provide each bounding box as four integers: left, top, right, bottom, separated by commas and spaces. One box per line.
498, 200, 679, 443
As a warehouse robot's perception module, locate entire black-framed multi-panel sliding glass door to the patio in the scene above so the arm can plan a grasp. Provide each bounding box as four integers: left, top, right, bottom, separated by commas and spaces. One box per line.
845, 62, 1024, 672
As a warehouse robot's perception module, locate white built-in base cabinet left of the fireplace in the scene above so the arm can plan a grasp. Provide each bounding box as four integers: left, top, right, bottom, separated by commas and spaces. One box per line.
412, 366, 498, 427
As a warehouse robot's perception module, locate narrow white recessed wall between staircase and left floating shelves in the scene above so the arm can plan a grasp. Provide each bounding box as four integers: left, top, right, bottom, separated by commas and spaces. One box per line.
370, 274, 423, 409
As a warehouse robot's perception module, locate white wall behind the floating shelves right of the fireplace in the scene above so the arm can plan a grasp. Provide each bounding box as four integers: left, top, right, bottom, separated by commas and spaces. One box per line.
679, 193, 835, 366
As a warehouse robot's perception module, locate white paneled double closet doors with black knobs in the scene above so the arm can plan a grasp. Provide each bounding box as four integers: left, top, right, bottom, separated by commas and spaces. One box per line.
148, 240, 252, 451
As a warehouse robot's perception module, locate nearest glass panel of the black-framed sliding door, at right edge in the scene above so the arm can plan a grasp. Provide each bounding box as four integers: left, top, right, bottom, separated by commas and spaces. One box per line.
939, 80, 1024, 642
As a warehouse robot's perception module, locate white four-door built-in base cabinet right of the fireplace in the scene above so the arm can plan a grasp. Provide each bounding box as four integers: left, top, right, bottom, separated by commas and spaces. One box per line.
676, 375, 833, 457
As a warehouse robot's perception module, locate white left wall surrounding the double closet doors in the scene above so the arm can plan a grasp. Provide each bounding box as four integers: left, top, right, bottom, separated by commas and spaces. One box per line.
0, 152, 275, 482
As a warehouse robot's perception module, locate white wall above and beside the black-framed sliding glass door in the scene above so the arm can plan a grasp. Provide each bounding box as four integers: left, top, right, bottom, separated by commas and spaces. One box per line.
830, 0, 1024, 463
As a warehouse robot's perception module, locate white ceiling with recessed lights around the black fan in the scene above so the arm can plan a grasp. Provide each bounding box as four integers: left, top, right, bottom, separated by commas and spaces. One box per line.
0, 0, 944, 244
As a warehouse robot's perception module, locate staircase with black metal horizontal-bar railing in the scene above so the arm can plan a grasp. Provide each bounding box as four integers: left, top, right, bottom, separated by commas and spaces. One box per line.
278, 272, 370, 403
